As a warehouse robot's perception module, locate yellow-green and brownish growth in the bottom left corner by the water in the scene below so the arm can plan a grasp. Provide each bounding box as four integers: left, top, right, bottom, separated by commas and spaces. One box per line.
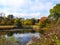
0, 35, 17, 45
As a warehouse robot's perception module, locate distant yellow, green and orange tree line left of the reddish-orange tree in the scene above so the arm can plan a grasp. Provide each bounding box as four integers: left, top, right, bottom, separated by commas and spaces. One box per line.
0, 14, 38, 26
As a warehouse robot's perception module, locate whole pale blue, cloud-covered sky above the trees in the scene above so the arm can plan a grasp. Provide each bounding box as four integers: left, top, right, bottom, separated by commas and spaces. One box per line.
0, 0, 60, 18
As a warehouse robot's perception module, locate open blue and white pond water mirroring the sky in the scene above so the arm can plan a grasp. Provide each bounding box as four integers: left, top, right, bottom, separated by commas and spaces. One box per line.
5, 33, 40, 45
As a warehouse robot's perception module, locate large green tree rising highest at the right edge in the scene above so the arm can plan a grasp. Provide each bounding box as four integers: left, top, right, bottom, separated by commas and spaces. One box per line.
48, 4, 60, 20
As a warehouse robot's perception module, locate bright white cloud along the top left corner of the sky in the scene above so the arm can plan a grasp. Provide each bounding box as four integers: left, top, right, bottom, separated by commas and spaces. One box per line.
0, 0, 25, 5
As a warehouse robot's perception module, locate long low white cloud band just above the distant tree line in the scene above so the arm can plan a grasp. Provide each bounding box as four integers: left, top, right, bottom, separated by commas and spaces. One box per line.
1, 10, 41, 19
